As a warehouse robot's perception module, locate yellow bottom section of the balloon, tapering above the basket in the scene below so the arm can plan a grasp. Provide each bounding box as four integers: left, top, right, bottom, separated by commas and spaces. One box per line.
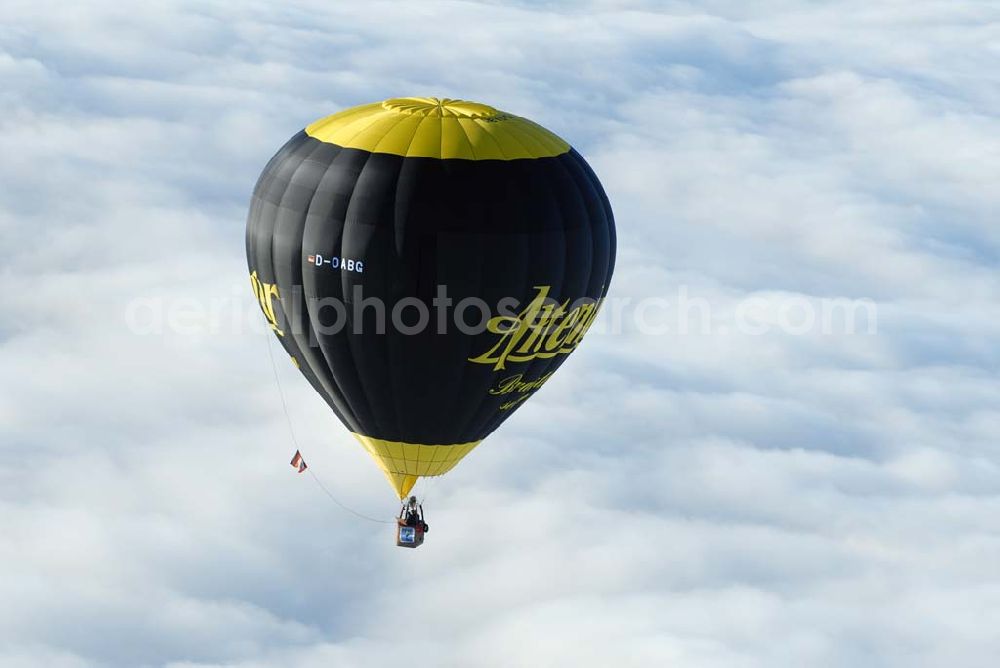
354, 433, 481, 499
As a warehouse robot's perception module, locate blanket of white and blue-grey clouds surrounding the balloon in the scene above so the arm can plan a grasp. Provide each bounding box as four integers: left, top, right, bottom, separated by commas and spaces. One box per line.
0, 0, 1000, 668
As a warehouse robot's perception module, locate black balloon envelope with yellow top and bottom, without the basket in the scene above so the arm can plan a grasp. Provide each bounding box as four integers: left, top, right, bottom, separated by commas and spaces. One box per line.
247, 97, 615, 497
